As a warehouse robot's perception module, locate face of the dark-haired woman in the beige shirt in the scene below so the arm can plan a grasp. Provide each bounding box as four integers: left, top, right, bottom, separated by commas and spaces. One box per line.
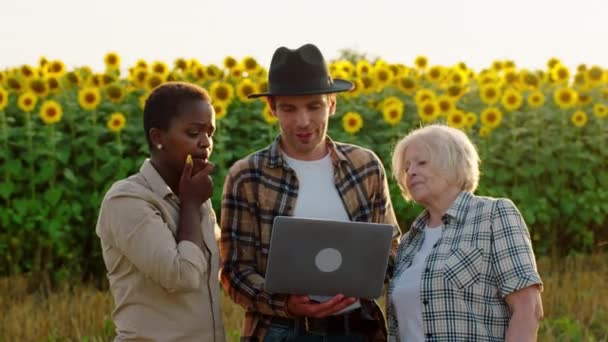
150, 100, 215, 183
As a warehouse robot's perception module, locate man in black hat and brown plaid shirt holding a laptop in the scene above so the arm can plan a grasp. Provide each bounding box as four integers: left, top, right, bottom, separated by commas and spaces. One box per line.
220, 44, 399, 342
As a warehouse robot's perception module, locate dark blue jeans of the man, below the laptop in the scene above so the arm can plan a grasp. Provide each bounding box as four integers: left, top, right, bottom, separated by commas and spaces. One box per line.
264, 324, 367, 342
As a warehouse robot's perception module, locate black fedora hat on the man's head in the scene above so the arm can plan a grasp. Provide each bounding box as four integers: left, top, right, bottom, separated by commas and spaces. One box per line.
248, 44, 354, 98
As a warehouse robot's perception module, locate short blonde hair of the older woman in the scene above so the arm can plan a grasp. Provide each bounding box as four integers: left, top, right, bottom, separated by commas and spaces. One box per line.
392, 124, 481, 200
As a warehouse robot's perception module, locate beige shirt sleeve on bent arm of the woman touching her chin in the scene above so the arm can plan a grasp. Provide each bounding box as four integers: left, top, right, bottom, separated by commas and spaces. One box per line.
99, 197, 208, 292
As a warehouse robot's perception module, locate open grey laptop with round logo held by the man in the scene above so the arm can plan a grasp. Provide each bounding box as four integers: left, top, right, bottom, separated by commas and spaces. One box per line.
264, 216, 395, 299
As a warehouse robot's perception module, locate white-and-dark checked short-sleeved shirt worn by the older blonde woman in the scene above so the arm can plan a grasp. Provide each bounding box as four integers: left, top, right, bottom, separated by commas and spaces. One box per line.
387, 192, 542, 341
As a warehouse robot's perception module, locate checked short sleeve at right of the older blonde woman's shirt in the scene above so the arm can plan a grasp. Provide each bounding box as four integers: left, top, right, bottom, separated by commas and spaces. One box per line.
492, 199, 542, 297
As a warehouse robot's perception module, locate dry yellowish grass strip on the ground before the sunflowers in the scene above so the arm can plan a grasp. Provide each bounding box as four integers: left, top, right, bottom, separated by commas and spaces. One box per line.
0, 254, 608, 341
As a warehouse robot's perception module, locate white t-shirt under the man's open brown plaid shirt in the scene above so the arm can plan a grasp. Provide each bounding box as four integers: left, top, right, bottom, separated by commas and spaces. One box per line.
283, 154, 361, 314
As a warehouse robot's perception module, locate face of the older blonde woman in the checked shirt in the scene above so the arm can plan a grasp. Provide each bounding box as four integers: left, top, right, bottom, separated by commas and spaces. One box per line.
404, 140, 453, 206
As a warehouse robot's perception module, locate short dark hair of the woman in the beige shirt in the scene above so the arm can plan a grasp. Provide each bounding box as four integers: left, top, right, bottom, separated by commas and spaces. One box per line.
144, 82, 211, 148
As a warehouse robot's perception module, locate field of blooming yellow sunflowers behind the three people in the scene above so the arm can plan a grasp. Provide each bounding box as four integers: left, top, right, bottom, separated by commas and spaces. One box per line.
0, 53, 608, 284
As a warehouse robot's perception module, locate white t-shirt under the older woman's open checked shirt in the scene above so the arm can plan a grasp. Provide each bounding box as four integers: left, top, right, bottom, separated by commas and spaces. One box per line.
391, 225, 443, 341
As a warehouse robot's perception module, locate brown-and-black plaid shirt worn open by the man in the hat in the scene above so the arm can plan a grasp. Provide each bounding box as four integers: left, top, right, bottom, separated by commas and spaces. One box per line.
220, 137, 400, 341
